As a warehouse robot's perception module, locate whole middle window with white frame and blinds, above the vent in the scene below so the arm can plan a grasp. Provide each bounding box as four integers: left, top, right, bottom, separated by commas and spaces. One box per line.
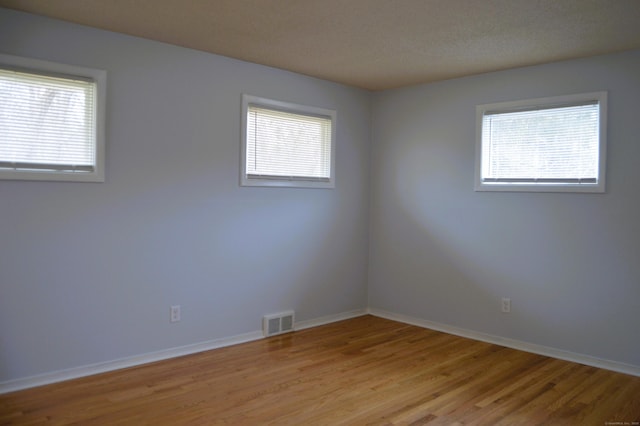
241, 95, 336, 188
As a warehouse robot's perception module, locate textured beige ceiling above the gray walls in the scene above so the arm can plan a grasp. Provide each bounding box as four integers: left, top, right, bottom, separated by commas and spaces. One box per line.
0, 0, 640, 90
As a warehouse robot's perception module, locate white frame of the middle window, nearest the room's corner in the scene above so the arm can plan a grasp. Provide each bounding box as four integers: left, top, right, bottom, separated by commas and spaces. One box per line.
240, 94, 337, 188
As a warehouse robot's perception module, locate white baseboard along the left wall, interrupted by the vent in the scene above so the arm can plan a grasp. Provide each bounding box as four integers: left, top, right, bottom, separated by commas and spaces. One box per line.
0, 309, 367, 395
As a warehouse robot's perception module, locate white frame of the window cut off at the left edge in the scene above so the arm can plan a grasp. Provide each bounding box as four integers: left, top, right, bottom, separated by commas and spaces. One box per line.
0, 54, 107, 182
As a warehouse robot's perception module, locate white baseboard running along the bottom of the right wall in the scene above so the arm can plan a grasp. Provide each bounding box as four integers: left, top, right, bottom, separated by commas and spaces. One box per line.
369, 308, 640, 377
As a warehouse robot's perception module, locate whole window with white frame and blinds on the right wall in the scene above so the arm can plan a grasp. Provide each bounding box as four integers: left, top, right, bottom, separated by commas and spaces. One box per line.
475, 92, 607, 192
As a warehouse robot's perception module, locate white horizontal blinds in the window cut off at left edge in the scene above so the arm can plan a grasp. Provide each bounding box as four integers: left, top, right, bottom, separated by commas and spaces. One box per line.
0, 69, 96, 173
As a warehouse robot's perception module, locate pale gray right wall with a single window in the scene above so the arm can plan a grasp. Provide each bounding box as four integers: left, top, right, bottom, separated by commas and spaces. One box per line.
369, 51, 640, 366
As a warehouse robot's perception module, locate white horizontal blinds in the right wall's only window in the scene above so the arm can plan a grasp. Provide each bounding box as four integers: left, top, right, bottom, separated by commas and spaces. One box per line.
482, 101, 599, 182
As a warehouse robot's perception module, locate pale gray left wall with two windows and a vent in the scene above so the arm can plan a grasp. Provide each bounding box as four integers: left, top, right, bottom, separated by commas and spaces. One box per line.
0, 9, 370, 382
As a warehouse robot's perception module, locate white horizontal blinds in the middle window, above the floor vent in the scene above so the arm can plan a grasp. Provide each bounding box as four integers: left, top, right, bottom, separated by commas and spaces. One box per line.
246, 104, 332, 182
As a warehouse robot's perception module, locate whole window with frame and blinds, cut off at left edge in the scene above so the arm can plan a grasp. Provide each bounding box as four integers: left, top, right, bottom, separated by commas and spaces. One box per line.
0, 55, 106, 182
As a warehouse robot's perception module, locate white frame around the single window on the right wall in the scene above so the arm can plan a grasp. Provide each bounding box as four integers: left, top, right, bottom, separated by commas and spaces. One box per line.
475, 91, 607, 193
